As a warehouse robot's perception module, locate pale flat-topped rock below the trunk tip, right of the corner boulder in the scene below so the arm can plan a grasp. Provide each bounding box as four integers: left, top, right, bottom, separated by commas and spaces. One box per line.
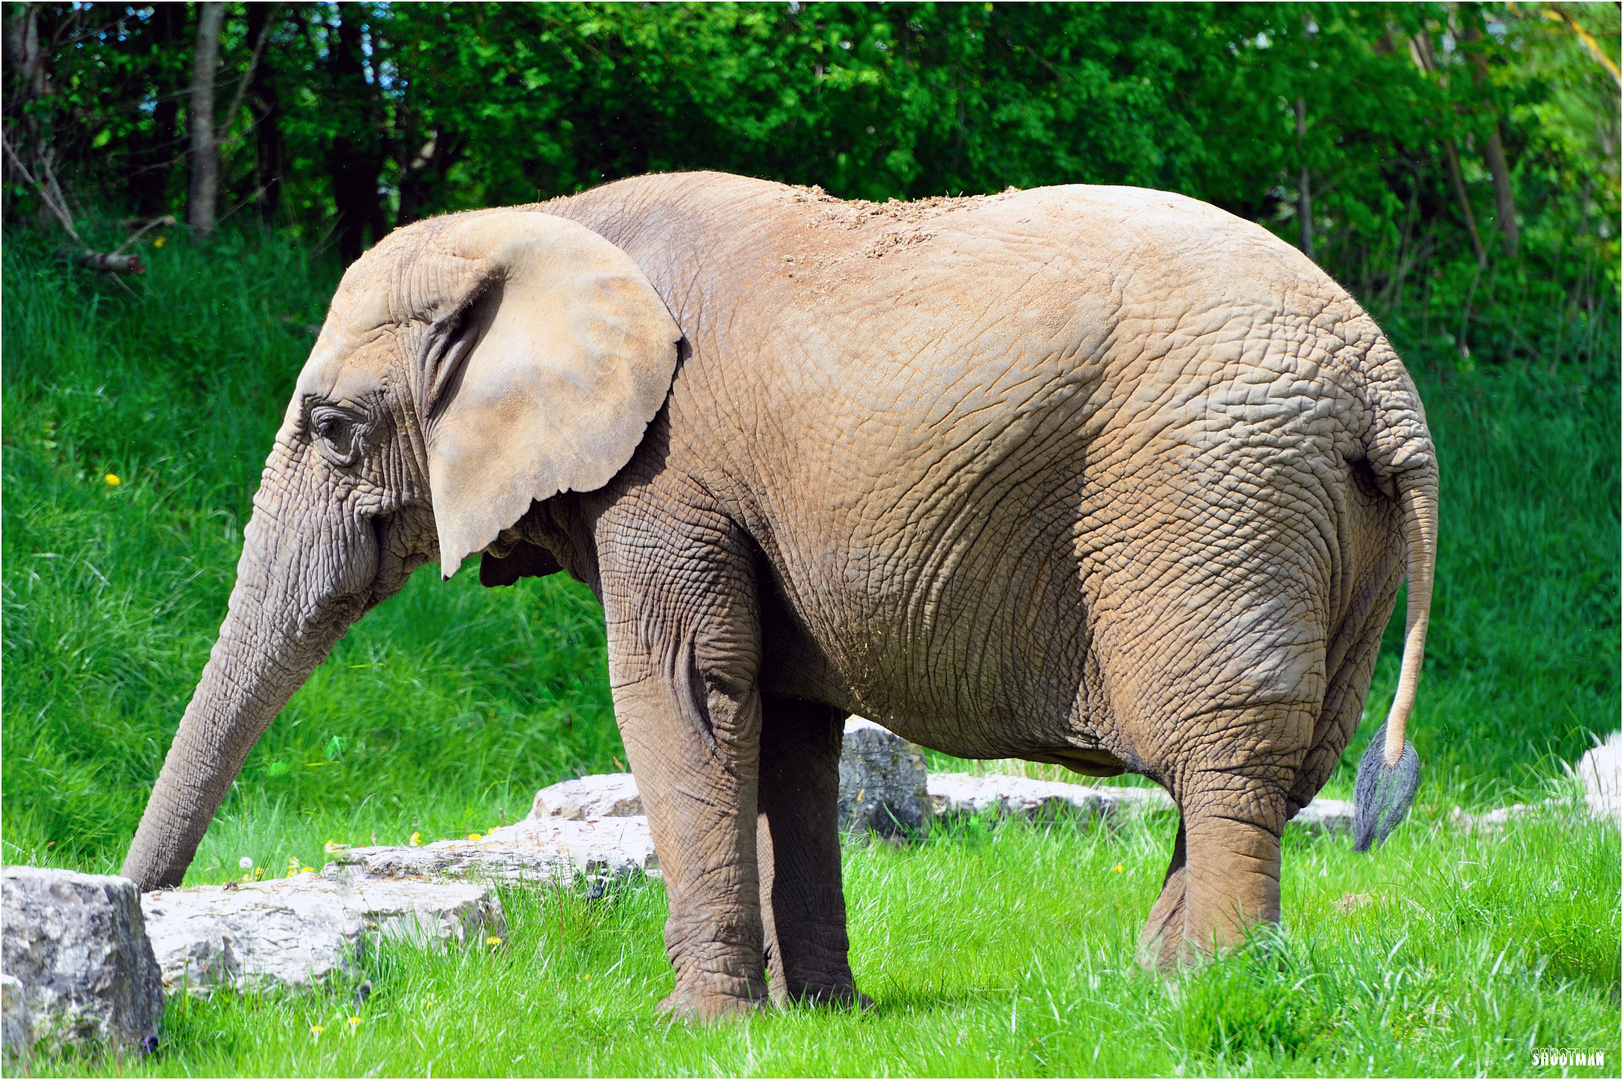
141, 874, 506, 992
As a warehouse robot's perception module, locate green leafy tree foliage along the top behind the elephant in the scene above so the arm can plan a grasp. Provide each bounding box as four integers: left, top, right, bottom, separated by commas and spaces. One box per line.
8, 2, 1620, 334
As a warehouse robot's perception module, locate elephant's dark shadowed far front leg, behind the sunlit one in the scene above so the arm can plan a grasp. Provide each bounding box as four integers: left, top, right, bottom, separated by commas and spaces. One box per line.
756, 695, 868, 1005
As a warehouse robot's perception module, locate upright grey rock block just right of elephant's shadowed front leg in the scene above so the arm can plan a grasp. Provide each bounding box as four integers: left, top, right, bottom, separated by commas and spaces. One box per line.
839, 716, 935, 836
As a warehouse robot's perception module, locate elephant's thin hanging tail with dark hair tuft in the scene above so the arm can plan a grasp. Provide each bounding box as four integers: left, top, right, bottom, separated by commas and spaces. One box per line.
1352, 370, 1438, 851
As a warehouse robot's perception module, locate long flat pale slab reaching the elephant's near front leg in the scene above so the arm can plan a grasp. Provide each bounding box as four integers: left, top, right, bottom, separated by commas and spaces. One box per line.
321, 817, 659, 883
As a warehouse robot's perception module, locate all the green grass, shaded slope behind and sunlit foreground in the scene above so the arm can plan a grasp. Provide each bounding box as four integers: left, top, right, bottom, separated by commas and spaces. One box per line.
0, 222, 1620, 1075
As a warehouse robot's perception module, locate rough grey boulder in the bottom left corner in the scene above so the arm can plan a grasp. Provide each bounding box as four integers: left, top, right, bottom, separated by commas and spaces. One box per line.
0, 866, 164, 1057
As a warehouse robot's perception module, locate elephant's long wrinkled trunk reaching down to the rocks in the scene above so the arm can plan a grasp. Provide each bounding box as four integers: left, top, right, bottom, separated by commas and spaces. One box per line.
122, 445, 378, 892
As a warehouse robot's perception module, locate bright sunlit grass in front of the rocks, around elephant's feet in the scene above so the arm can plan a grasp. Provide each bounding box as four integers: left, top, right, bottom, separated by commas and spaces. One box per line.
25, 808, 1623, 1077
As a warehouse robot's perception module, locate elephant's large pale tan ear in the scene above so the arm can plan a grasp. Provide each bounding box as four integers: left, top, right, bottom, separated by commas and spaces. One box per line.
420, 211, 682, 577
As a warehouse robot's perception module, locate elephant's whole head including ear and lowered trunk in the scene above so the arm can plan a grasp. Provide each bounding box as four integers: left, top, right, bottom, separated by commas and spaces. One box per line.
123, 211, 682, 890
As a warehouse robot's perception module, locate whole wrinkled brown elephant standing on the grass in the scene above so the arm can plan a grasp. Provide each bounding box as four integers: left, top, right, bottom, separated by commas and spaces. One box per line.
123, 172, 1438, 1020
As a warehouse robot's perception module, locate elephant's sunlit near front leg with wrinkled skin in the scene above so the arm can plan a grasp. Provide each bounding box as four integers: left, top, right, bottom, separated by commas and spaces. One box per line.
602, 519, 768, 1020
